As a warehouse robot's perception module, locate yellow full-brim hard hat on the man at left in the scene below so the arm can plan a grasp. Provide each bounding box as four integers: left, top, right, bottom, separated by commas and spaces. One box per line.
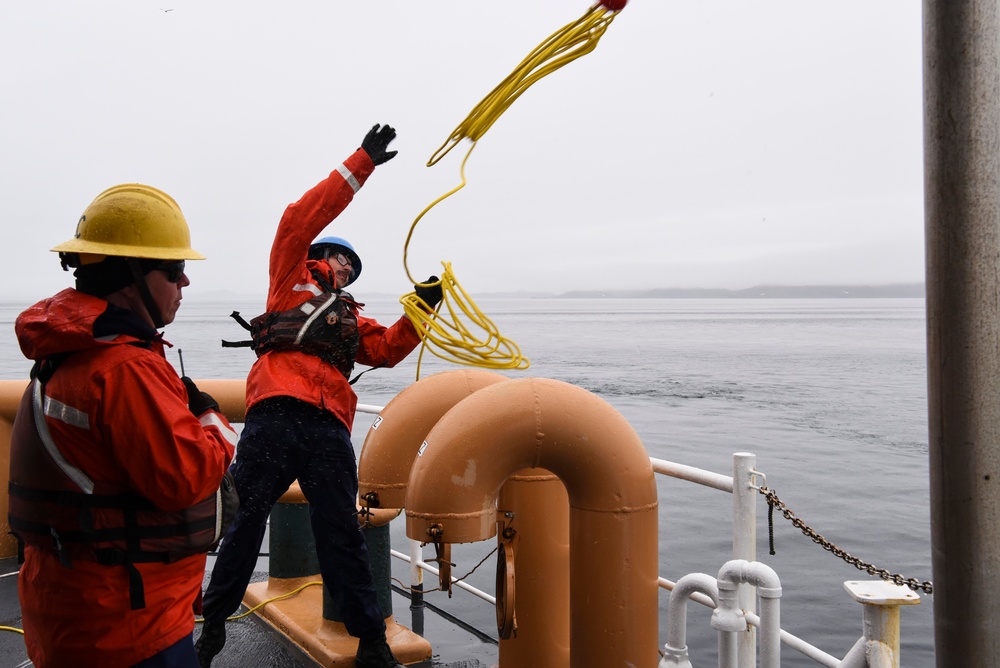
52, 183, 205, 260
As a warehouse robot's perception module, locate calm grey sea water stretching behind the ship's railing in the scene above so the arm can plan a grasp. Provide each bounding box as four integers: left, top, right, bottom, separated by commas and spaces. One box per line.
0, 299, 934, 667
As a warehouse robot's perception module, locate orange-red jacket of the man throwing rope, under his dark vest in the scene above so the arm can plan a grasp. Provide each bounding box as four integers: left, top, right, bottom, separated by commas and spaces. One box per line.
247, 148, 420, 429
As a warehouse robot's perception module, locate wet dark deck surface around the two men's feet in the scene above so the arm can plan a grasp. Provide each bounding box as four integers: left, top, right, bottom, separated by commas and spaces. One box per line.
0, 558, 497, 668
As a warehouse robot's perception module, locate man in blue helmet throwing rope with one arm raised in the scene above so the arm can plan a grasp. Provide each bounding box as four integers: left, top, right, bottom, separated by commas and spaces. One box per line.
196, 125, 441, 668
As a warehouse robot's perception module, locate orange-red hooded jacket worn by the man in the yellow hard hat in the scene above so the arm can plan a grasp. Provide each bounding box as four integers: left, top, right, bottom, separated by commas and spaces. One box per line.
11, 289, 236, 668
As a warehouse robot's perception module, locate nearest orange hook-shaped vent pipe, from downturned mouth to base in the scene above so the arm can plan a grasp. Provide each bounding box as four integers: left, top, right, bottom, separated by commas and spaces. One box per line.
406, 378, 659, 668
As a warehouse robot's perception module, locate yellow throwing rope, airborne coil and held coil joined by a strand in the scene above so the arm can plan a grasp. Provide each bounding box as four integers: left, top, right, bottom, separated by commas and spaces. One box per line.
399, 0, 627, 378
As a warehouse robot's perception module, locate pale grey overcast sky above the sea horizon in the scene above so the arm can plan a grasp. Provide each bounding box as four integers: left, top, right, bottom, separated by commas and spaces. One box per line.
0, 0, 923, 298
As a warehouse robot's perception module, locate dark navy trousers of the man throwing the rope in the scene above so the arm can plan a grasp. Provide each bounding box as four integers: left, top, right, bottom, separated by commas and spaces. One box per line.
204, 397, 385, 638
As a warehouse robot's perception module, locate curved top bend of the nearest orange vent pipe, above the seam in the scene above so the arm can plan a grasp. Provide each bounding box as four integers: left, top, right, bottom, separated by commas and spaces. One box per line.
406, 378, 657, 543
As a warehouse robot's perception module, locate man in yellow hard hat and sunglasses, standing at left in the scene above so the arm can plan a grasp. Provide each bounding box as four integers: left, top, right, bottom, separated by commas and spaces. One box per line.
9, 184, 236, 668
